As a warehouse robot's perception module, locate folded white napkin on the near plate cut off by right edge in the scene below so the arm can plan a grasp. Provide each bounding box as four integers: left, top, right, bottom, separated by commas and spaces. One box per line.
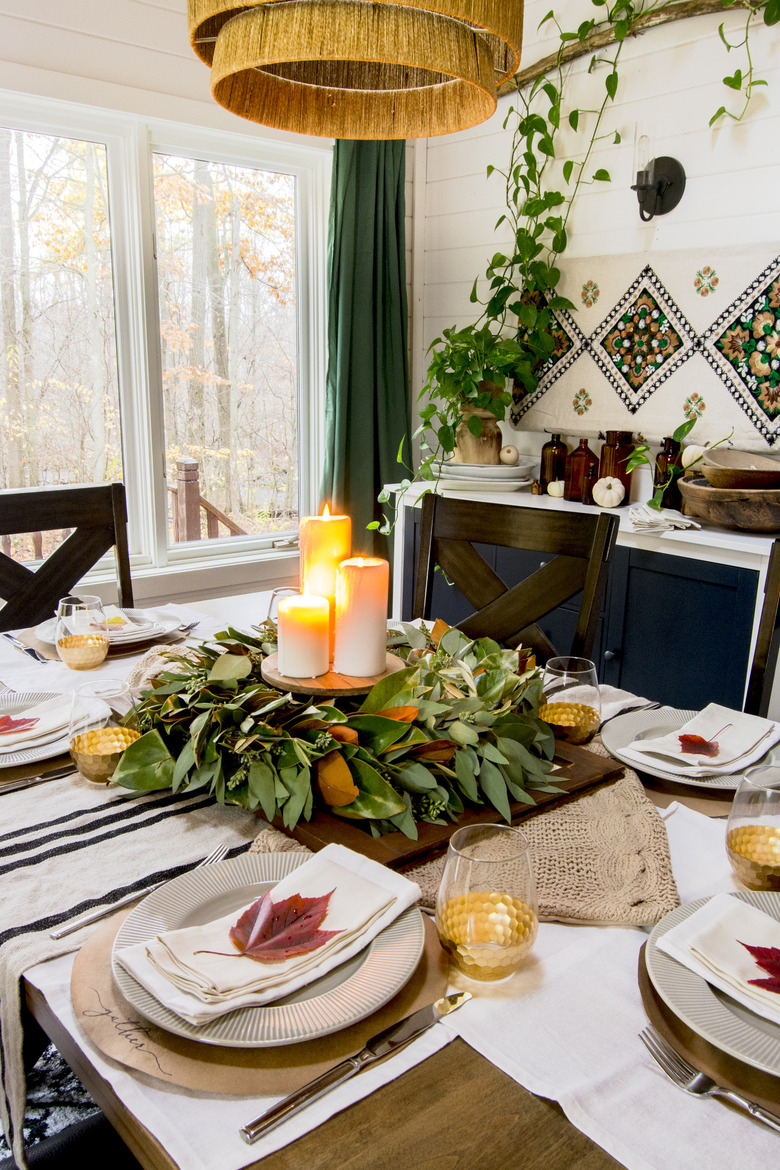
658, 894, 780, 1024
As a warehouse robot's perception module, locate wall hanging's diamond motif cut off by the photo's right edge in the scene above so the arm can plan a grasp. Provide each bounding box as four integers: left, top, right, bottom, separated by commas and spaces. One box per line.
703, 256, 780, 446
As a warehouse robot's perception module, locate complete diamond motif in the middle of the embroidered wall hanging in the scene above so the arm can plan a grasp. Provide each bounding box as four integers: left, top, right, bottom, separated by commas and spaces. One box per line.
587, 266, 696, 414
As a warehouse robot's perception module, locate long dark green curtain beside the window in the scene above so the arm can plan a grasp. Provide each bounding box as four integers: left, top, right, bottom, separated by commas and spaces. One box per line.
322, 140, 409, 557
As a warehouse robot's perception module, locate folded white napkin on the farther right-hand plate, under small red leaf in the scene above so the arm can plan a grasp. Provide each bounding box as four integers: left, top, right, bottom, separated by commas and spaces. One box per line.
623, 703, 780, 776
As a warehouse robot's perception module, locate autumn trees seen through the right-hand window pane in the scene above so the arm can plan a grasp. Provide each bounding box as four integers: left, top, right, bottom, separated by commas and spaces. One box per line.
154, 154, 298, 539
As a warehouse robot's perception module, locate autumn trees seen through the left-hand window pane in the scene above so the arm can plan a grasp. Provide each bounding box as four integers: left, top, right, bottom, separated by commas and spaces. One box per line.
0, 128, 123, 559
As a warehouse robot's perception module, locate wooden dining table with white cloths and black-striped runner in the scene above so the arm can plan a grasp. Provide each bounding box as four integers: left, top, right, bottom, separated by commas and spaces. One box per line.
0, 593, 780, 1170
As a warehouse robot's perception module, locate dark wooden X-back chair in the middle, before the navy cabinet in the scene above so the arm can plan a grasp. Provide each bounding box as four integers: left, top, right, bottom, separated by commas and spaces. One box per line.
414, 494, 619, 661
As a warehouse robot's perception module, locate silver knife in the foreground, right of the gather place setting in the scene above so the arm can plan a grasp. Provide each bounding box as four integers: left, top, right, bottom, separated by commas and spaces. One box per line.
239, 991, 471, 1145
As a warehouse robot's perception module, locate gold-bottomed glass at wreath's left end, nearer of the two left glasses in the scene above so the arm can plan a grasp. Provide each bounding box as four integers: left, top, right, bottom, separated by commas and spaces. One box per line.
68, 679, 140, 784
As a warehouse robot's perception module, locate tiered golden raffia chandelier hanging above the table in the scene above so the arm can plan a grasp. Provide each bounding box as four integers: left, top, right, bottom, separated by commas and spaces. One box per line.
187, 0, 523, 139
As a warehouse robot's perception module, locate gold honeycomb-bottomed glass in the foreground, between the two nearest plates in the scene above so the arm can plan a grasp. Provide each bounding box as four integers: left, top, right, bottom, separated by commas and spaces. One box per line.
436, 825, 539, 983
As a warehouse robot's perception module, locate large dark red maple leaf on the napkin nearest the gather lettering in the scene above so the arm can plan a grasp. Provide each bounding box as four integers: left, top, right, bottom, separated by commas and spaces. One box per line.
224, 890, 341, 963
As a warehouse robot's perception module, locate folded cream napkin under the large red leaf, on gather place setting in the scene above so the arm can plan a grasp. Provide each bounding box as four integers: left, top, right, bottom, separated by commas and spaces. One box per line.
117, 845, 420, 1026
